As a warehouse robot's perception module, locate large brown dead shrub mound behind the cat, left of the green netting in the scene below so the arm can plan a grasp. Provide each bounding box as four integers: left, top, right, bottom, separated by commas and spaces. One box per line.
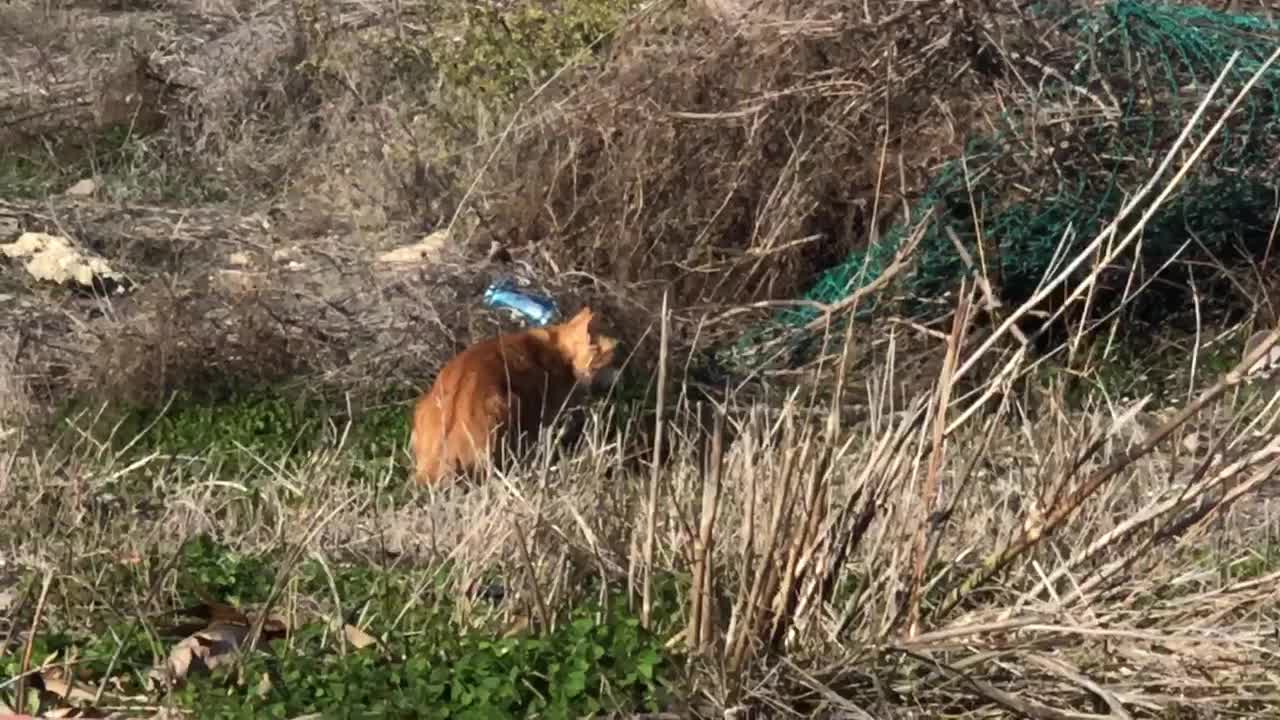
481, 3, 1044, 306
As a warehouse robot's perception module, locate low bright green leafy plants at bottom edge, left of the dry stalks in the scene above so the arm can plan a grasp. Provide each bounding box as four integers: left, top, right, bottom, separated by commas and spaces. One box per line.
178, 591, 672, 719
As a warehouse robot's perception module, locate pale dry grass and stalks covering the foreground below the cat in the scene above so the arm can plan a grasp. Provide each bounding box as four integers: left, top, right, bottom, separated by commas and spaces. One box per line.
4, 310, 1280, 717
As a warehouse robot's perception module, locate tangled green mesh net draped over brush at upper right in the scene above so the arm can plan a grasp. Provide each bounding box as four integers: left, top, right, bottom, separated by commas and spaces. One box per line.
733, 0, 1280, 368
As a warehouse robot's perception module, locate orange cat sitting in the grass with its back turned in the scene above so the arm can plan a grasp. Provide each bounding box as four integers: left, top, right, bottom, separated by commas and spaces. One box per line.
410, 307, 617, 483
